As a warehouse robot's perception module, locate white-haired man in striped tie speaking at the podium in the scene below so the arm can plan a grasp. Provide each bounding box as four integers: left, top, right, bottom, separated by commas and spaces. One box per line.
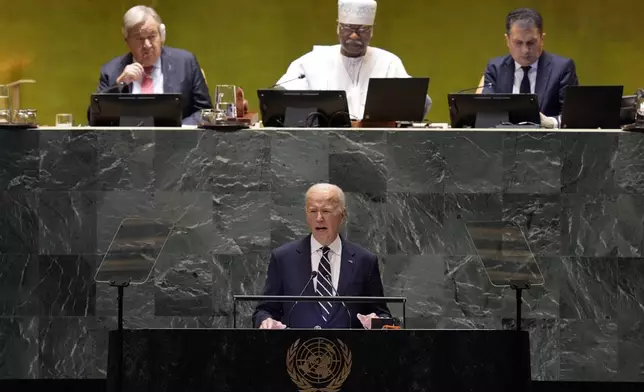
253, 184, 391, 329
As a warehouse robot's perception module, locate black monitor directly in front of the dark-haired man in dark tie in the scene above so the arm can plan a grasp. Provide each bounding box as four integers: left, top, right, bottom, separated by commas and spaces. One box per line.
447, 93, 541, 128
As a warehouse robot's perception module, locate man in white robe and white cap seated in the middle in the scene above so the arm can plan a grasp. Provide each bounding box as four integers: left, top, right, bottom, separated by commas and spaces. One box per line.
276, 0, 431, 120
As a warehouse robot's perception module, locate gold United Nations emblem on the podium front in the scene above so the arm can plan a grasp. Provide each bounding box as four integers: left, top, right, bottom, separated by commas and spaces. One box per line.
286, 338, 351, 392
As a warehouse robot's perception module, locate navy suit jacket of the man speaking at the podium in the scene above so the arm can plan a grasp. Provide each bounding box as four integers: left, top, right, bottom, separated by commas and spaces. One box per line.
253, 235, 391, 328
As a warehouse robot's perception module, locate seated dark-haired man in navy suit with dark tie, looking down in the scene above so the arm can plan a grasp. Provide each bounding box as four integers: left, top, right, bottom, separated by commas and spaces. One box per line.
483, 8, 579, 128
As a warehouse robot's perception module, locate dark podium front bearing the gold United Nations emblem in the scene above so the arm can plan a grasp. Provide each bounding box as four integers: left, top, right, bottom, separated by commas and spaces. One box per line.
107, 329, 530, 392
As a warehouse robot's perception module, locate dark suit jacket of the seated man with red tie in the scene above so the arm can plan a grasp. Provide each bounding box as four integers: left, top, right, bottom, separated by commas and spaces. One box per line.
88, 46, 212, 125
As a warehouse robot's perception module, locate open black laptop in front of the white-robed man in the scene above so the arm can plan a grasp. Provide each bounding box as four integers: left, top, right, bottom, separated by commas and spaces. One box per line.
362, 78, 429, 122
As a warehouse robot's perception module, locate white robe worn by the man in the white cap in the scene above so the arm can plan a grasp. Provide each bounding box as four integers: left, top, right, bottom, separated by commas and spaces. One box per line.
277, 45, 431, 120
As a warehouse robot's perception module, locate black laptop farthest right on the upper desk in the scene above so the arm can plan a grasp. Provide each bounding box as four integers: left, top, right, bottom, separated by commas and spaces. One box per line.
561, 86, 624, 129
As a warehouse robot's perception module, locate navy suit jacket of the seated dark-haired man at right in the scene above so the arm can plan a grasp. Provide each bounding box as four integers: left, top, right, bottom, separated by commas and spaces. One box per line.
483, 52, 579, 117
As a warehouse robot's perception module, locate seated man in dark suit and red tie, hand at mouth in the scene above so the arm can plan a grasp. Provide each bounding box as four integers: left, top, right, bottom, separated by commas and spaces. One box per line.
92, 5, 212, 125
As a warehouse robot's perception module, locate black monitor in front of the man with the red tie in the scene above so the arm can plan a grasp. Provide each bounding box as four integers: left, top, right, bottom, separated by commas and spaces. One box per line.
89, 93, 183, 127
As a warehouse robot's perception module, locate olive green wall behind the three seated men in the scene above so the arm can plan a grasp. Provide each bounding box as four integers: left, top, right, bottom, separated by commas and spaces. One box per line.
0, 0, 644, 125
